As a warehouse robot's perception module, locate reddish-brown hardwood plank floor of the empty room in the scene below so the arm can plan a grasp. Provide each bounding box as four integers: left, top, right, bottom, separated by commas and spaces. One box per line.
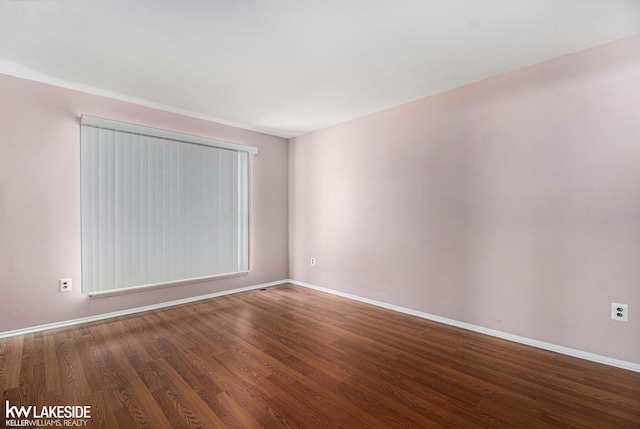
0, 285, 640, 429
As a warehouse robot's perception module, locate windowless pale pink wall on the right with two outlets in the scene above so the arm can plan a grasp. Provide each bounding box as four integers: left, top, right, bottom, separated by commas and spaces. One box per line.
289, 37, 640, 363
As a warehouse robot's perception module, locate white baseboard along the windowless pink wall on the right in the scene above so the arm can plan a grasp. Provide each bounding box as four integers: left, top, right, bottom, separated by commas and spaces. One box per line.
287, 279, 640, 372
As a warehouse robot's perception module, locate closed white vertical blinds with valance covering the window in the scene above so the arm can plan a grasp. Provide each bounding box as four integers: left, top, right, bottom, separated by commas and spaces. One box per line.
80, 116, 256, 294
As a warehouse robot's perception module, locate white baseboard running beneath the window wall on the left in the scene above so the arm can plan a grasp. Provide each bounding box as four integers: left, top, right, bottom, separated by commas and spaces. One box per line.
0, 280, 289, 338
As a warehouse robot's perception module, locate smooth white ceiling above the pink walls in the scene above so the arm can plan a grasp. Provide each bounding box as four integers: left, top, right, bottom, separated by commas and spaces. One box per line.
0, 0, 640, 137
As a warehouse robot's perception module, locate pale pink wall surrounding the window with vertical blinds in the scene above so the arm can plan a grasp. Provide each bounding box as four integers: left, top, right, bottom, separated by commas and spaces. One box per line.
0, 75, 288, 332
